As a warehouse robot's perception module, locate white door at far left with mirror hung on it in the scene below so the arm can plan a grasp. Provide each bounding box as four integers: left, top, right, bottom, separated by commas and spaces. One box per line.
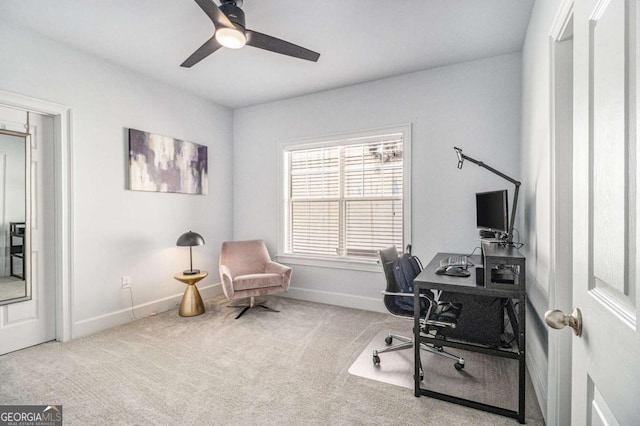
0, 110, 56, 354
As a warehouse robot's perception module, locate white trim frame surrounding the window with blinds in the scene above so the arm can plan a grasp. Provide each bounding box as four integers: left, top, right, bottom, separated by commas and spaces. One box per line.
276, 124, 412, 272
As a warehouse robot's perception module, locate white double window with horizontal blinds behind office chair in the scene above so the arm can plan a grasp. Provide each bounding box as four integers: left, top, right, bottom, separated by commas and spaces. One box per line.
280, 126, 410, 270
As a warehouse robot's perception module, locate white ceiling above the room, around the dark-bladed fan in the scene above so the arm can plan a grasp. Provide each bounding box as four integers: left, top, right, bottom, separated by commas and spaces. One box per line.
0, 0, 534, 108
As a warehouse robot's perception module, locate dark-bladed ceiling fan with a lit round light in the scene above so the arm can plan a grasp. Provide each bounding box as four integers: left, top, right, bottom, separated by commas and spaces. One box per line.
180, 0, 320, 68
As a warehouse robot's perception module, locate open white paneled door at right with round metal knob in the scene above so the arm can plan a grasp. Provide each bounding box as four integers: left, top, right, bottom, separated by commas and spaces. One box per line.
572, 0, 640, 425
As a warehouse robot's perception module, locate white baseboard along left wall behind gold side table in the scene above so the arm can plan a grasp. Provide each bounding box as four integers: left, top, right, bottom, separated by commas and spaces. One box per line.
72, 283, 222, 339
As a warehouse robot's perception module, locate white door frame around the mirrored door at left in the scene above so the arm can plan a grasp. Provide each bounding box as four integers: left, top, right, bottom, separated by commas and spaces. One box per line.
0, 90, 73, 342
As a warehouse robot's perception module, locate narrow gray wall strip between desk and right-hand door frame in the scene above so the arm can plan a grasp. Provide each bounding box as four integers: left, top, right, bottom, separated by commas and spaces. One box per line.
521, 0, 571, 425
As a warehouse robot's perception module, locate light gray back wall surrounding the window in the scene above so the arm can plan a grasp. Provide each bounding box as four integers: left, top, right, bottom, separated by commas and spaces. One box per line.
233, 54, 521, 310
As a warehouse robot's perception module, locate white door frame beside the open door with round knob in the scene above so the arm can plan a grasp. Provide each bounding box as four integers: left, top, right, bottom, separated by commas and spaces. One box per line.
546, 0, 574, 425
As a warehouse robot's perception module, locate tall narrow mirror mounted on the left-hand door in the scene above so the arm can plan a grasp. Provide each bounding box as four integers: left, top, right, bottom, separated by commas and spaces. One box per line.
0, 130, 31, 305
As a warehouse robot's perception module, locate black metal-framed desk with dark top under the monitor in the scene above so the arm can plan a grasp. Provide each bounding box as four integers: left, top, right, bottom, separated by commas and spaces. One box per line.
413, 253, 526, 423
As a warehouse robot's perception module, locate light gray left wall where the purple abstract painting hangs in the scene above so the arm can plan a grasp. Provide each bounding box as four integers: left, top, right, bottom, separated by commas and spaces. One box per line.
0, 23, 233, 337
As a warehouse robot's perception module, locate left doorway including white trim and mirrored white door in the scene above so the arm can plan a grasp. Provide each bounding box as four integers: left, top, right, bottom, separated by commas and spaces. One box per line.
0, 92, 72, 355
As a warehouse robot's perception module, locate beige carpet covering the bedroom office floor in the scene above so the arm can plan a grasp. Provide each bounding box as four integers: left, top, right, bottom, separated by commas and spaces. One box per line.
0, 297, 540, 426
